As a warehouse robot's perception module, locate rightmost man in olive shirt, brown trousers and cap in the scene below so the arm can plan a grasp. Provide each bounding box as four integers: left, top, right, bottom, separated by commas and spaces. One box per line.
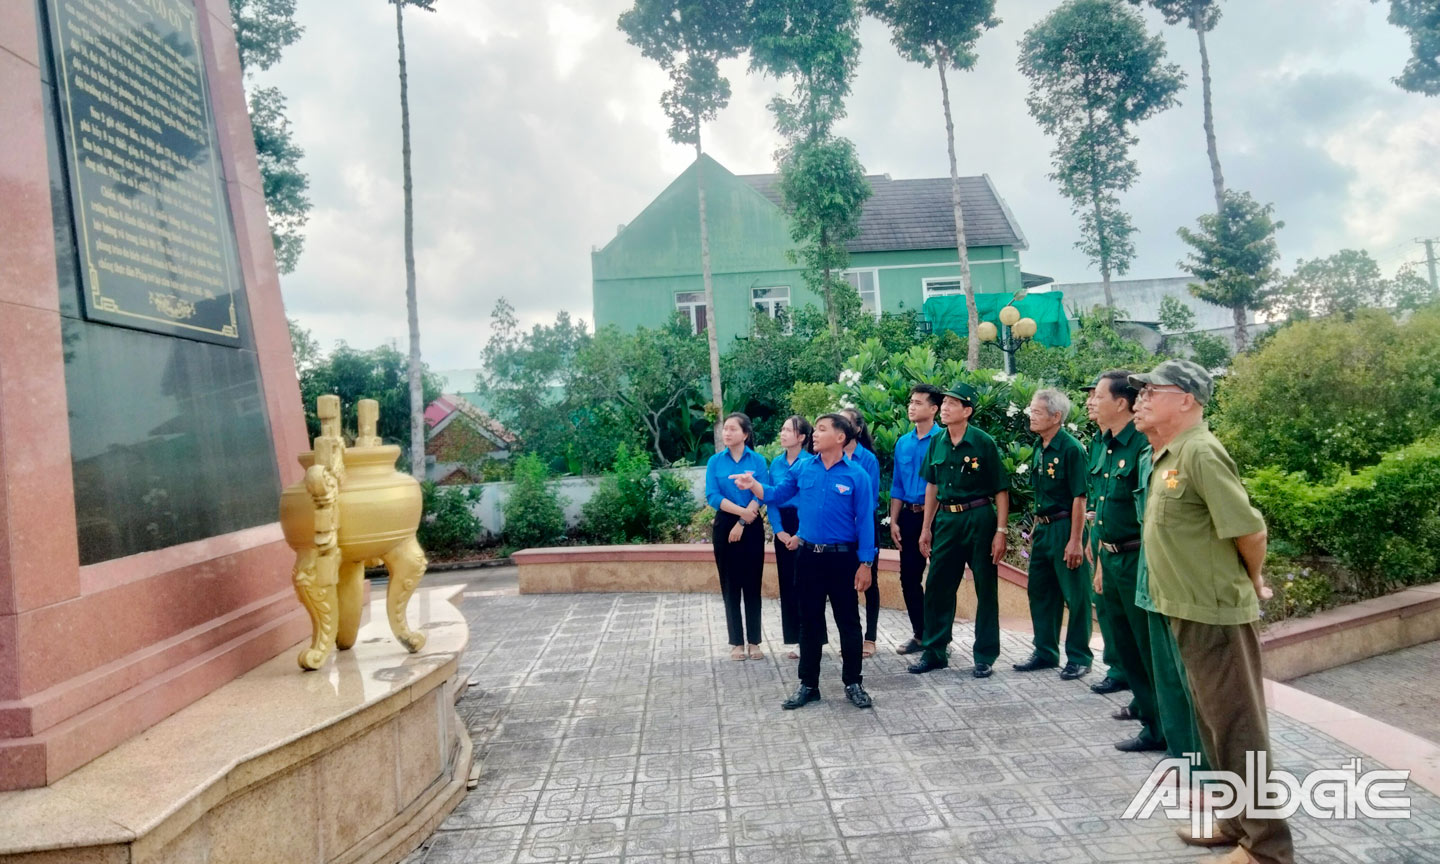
1130, 360, 1295, 864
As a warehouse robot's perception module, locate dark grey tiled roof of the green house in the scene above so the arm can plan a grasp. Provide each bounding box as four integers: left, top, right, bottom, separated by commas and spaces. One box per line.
739, 168, 1030, 252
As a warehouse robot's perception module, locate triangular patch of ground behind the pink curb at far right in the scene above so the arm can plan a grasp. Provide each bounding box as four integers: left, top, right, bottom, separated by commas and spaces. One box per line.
1287, 642, 1440, 743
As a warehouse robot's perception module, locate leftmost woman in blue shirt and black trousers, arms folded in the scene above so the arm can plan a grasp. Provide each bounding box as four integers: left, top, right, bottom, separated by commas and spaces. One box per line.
706, 412, 770, 660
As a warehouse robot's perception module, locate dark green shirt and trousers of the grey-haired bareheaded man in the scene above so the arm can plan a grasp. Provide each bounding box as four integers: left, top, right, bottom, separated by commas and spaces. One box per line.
1025, 429, 1093, 667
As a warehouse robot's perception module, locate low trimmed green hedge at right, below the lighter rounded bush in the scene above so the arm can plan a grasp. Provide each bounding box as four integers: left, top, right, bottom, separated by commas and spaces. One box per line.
1246, 438, 1440, 593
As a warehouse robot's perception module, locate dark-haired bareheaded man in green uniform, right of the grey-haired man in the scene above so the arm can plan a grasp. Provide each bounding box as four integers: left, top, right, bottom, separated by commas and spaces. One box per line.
1090, 369, 1165, 753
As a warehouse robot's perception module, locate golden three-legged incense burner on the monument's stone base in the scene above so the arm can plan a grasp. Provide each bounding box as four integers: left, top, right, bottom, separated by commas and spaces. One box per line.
279, 396, 428, 670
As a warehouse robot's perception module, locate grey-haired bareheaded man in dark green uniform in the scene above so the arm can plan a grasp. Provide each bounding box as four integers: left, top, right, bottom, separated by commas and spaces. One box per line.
1015, 389, 1094, 681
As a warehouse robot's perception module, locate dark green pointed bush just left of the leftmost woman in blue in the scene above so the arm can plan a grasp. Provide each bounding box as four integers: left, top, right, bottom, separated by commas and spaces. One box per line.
580, 444, 700, 543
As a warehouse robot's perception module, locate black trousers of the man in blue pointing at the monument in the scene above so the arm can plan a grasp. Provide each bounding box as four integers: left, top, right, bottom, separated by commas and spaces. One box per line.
795, 547, 863, 687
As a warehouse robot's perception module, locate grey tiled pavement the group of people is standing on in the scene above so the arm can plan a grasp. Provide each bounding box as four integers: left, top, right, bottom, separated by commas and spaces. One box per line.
408, 593, 1440, 864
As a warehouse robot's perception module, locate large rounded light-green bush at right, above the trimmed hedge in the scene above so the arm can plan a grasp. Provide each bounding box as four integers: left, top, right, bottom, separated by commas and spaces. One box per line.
1214, 308, 1440, 480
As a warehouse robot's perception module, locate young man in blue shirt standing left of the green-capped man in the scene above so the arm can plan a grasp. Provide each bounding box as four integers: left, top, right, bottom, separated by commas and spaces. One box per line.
890, 384, 945, 654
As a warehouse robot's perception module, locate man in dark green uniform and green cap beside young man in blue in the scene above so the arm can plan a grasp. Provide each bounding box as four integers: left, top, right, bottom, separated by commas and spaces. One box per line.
910, 383, 1009, 678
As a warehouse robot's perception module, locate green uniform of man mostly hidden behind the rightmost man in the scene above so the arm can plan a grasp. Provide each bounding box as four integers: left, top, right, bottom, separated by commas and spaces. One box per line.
1135, 446, 1210, 770
